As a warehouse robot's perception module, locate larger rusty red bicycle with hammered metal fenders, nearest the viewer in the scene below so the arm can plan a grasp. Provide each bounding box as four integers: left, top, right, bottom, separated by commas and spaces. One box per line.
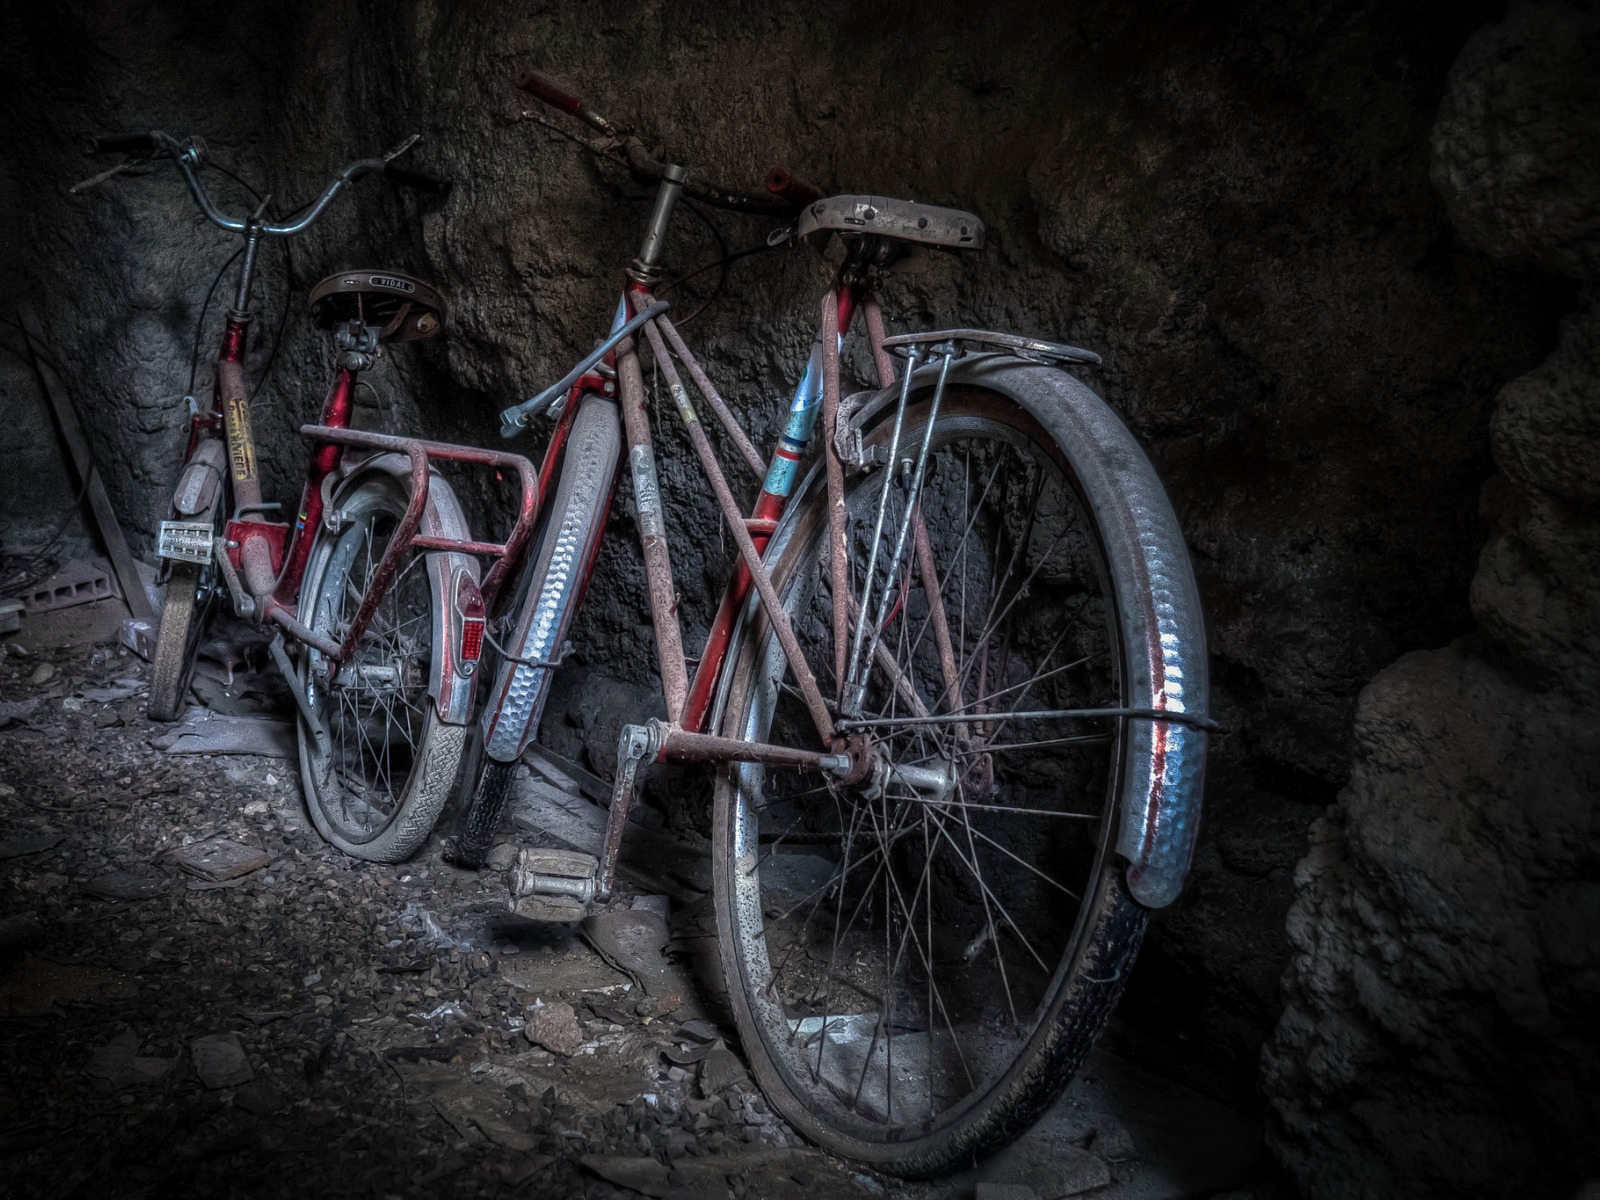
458, 74, 1211, 1173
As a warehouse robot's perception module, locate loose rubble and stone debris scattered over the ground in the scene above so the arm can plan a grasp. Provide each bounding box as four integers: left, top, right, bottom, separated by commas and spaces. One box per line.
0, 633, 1235, 1200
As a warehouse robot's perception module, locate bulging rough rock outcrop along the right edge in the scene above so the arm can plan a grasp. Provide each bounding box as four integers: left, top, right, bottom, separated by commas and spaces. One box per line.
1264, 5, 1600, 1200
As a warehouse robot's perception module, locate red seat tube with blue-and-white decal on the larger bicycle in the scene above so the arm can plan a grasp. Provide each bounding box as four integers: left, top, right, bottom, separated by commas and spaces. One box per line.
683, 286, 861, 733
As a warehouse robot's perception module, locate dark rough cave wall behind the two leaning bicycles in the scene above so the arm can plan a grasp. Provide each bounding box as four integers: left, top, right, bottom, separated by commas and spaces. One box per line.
0, 0, 1570, 1164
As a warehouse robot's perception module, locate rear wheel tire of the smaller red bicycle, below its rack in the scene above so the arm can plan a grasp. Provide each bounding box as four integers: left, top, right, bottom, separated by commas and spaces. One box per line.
296, 469, 467, 862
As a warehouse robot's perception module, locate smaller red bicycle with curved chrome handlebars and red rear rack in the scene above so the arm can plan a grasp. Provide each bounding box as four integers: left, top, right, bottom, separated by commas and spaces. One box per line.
90, 131, 538, 862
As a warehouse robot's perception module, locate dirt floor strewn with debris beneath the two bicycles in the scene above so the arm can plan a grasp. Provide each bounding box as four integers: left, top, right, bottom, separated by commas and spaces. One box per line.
0, 633, 1259, 1200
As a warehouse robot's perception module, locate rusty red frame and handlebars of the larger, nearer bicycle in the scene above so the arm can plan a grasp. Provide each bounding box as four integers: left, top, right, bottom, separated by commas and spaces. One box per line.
485, 72, 985, 898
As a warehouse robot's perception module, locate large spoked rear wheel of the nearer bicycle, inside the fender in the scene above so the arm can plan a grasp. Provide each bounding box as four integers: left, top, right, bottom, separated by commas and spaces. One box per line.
712, 365, 1205, 1174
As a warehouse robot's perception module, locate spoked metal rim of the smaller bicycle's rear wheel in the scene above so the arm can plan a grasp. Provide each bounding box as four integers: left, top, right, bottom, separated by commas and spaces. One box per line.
307, 498, 432, 843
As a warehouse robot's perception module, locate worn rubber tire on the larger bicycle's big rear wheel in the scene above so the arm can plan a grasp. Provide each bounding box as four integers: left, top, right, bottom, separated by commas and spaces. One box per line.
712, 360, 1205, 1176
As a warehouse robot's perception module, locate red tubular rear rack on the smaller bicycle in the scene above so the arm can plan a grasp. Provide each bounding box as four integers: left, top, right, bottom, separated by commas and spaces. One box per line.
289, 426, 539, 662
